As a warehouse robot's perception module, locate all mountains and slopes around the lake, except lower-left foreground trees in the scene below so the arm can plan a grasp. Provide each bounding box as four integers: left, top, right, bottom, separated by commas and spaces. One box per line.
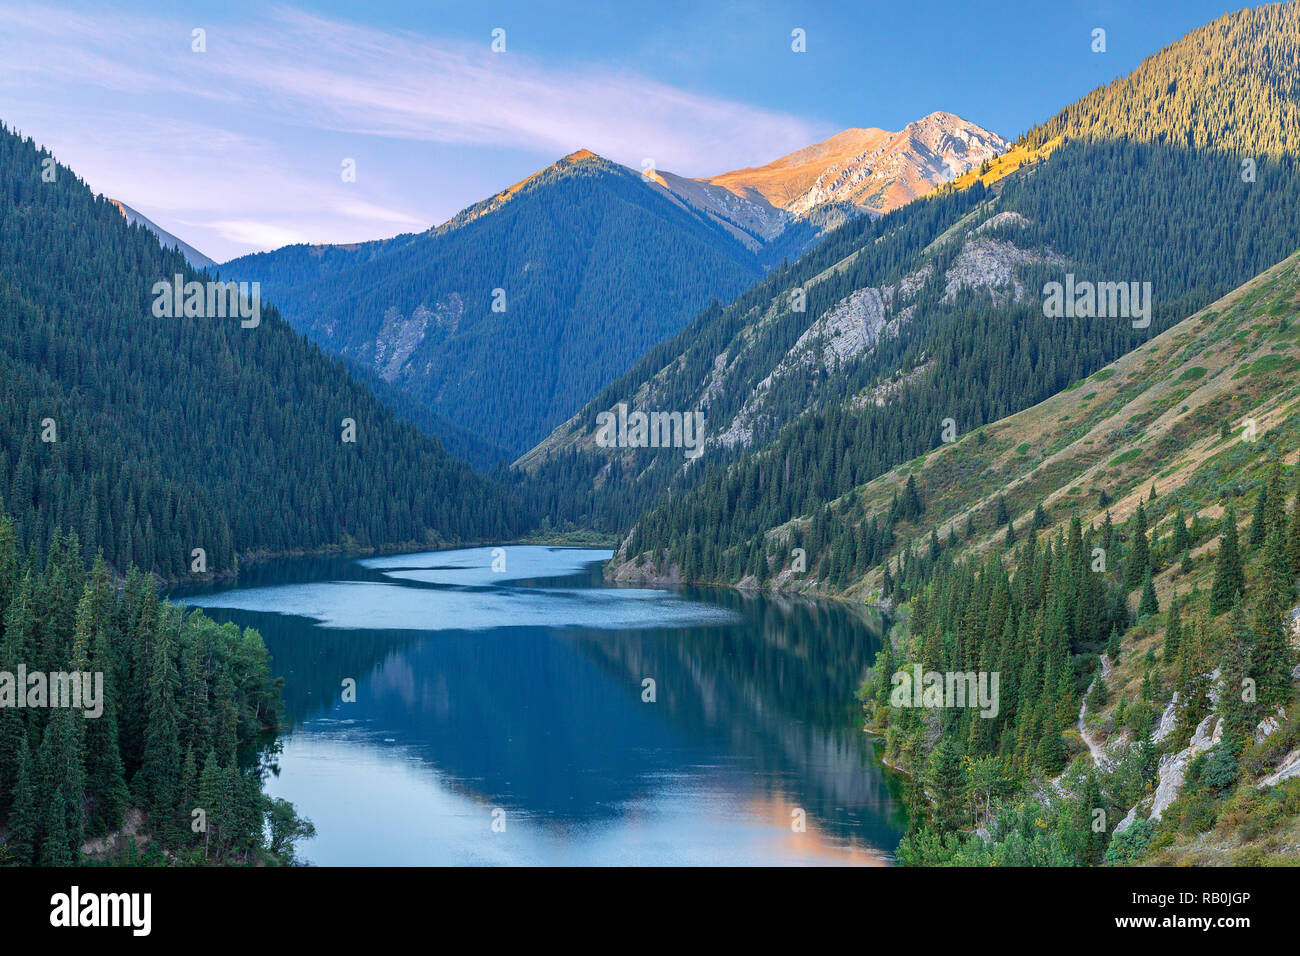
10, 3, 1300, 866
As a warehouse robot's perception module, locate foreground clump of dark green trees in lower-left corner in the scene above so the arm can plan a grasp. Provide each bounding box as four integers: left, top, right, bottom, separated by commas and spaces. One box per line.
0, 515, 311, 866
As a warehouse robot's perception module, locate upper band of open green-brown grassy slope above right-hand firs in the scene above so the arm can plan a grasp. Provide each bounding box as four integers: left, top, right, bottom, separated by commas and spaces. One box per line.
795, 256, 1300, 598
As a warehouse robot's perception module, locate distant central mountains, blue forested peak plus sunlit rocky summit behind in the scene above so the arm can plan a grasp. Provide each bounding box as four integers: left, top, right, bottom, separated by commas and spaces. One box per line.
221, 113, 1006, 458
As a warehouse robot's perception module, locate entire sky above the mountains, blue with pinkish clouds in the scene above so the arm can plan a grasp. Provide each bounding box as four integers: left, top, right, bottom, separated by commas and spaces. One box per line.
0, 0, 1263, 260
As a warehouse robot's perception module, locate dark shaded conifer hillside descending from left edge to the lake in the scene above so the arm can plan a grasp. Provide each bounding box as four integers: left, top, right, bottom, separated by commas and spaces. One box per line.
0, 119, 525, 579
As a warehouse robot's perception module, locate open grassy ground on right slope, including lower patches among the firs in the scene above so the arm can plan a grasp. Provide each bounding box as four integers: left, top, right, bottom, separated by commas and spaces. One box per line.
821, 254, 1300, 864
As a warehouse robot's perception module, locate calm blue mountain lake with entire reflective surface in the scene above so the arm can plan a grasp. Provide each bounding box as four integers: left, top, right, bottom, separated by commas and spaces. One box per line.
174, 546, 906, 866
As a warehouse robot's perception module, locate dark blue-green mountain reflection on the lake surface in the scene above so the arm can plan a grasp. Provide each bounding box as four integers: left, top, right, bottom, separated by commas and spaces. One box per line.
175, 548, 904, 849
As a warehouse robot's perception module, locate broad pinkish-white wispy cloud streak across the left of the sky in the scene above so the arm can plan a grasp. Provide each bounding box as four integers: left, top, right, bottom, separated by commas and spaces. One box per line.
0, 4, 829, 258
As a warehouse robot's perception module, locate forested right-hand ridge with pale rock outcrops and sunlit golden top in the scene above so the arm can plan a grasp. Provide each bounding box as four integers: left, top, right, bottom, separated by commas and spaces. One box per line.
521, 4, 1300, 590
